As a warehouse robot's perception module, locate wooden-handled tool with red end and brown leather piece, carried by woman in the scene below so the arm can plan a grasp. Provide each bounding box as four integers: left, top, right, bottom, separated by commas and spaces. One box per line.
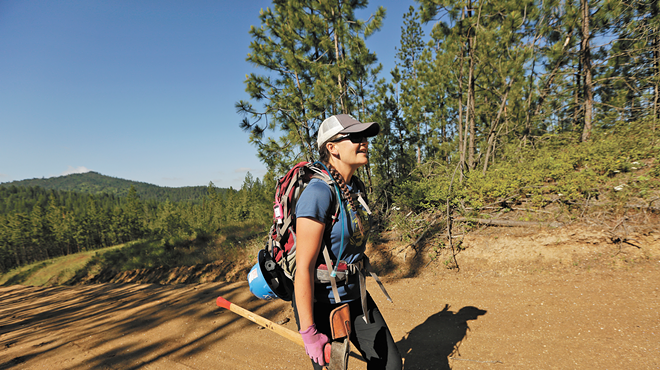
215, 297, 351, 370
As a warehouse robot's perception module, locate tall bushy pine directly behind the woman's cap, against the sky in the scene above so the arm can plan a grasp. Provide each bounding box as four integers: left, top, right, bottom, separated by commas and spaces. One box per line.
236, 0, 385, 174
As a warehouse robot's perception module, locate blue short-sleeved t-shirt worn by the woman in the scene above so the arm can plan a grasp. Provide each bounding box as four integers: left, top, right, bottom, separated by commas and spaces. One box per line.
296, 179, 370, 303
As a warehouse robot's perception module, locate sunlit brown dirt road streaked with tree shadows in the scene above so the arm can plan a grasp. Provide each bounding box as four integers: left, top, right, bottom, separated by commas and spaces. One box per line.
0, 227, 660, 370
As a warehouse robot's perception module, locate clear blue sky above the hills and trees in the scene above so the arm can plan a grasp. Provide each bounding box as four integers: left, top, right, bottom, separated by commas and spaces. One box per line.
0, 0, 417, 188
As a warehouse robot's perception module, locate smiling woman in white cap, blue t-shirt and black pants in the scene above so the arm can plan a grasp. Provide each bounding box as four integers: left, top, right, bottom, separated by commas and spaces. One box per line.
293, 114, 402, 369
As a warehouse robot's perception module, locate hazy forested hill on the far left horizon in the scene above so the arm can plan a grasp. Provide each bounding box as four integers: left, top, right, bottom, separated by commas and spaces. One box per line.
0, 172, 214, 202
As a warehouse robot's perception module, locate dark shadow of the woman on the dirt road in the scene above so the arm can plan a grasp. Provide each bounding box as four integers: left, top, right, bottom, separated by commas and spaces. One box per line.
397, 305, 487, 370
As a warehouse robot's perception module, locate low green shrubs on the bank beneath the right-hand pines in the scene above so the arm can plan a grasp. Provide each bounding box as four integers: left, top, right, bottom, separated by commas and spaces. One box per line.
394, 121, 660, 211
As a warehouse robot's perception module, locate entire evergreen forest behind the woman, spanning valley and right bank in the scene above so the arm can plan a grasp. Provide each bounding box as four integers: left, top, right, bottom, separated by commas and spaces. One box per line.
0, 0, 660, 271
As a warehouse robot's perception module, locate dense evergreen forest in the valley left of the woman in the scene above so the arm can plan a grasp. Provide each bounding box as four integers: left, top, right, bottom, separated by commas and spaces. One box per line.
0, 173, 270, 273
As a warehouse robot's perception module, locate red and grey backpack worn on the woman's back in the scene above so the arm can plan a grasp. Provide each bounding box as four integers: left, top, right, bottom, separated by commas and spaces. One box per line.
253, 162, 341, 301
